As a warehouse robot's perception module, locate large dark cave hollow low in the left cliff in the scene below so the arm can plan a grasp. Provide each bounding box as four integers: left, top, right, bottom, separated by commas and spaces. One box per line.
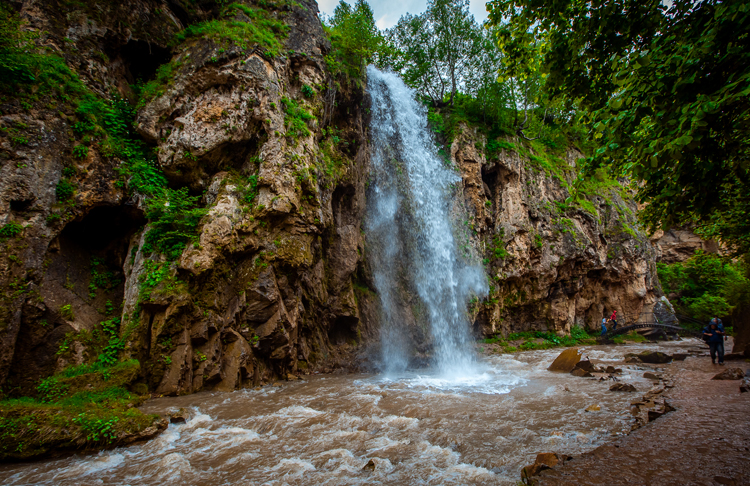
8, 206, 146, 390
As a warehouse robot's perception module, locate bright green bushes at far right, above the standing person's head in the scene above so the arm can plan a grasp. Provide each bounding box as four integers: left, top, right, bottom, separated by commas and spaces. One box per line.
657, 251, 750, 320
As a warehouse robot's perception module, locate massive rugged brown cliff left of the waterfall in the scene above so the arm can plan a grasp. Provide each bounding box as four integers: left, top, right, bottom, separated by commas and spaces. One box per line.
0, 1, 372, 394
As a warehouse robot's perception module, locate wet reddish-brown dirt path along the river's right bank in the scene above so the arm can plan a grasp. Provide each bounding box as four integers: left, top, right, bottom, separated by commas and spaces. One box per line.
537, 346, 750, 486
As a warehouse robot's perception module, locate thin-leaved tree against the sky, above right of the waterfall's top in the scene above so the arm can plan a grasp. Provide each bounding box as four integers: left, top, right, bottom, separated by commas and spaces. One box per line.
388, 0, 481, 106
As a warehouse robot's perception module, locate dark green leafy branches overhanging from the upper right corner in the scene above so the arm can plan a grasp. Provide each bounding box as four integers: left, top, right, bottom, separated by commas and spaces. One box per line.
488, 0, 750, 253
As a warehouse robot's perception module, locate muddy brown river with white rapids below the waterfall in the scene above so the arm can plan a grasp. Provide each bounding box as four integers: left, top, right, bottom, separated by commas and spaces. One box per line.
0, 340, 697, 486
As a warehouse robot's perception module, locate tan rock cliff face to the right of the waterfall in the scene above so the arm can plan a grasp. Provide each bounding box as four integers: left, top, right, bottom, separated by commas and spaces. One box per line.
451, 125, 666, 335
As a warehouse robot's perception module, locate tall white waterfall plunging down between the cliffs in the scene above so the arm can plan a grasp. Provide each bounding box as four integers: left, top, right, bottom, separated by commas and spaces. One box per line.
366, 66, 487, 375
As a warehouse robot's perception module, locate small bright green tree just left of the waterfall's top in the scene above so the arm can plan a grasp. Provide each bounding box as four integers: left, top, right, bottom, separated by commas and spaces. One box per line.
324, 0, 383, 85
